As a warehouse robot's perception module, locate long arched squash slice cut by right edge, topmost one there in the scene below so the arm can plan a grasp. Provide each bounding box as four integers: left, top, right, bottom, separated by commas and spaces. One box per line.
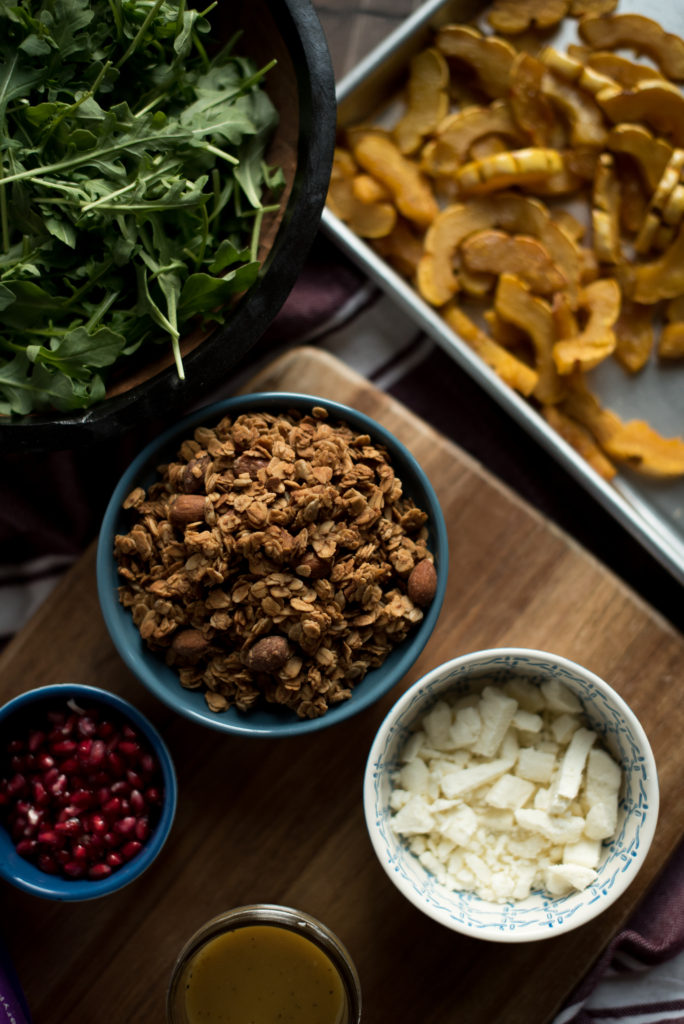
578, 14, 684, 82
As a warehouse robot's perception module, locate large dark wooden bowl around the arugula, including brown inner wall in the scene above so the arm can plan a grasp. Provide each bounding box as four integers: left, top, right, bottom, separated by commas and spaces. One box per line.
0, 0, 336, 455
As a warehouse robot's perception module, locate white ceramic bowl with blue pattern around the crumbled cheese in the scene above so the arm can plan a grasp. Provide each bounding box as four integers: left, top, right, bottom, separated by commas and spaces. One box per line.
364, 647, 658, 942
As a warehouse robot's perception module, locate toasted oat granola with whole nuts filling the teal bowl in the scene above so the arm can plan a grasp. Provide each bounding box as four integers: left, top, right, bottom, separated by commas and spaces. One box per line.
115, 407, 434, 718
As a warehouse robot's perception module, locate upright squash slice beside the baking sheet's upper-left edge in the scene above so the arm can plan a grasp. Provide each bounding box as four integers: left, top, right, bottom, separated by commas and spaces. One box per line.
392, 46, 450, 155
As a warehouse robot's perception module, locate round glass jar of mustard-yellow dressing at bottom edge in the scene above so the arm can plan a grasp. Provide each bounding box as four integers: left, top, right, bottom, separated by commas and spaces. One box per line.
167, 903, 361, 1024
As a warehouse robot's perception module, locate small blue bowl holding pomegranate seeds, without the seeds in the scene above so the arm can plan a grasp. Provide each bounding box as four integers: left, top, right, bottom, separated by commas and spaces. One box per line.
0, 683, 177, 901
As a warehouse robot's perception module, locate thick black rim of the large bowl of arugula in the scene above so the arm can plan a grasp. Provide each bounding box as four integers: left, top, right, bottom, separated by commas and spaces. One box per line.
0, 0, 337, 455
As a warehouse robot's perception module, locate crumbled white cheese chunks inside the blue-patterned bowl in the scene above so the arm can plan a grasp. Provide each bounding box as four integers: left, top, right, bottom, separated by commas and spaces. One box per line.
390, 679, 622, 901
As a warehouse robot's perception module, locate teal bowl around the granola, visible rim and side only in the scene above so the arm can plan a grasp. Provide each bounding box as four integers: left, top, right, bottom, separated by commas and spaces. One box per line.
95, 391, 448, 738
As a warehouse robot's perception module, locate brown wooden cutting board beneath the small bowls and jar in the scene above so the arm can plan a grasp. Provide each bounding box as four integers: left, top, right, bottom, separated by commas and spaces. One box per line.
0, 348, 684, 1024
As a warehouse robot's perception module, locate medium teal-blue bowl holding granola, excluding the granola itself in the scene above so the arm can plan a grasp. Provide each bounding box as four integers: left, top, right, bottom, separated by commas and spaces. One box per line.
97, 392, 448, 737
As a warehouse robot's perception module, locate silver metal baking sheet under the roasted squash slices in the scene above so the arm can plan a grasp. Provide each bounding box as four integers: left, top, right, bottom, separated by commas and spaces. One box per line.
322, 0, 684, 583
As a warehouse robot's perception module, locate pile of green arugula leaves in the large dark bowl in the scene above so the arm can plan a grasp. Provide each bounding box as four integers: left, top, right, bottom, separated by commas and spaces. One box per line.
0, 0, 284, 416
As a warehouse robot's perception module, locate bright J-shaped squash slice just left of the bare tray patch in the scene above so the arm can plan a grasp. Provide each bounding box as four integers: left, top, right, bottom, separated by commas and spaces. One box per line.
553, 278, 622, 375
